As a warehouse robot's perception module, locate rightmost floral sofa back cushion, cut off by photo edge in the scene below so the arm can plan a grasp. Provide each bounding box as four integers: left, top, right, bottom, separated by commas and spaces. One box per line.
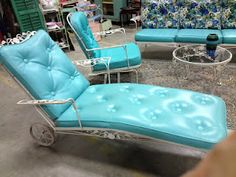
222, 0, 236, 29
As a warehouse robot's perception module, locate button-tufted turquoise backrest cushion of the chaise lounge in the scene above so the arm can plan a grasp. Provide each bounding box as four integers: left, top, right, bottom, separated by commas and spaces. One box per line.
0, 30, 89, 119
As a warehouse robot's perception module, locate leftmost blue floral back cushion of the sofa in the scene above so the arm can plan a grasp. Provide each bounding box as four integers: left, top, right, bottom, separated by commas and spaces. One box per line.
141, 0, 179, 28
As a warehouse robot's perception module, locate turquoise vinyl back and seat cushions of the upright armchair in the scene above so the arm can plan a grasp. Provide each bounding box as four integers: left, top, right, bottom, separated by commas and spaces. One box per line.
70, 12, 141, 71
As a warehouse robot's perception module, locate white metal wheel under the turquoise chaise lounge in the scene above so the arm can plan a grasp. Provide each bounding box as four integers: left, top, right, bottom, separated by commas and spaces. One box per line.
30, 123, 55, 146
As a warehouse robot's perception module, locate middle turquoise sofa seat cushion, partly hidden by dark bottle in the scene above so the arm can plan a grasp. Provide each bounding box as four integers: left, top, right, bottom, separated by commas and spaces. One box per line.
176, 29, 223, 44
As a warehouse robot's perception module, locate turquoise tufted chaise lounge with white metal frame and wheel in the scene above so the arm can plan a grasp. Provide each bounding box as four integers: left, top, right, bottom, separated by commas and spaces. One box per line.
0, 30, 227, 149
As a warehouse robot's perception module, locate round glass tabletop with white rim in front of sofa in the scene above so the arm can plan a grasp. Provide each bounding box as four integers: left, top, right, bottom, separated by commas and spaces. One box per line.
173, 44, 232, 66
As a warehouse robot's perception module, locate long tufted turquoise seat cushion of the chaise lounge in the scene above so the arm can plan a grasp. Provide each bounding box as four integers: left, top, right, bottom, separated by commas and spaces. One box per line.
56, 84, 227, 148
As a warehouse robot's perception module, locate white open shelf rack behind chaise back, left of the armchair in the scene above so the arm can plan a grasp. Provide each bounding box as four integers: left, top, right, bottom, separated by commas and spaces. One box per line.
41, 7, 70, 50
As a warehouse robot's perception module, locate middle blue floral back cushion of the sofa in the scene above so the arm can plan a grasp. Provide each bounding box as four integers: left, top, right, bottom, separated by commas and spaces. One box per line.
178, 0, 221, 29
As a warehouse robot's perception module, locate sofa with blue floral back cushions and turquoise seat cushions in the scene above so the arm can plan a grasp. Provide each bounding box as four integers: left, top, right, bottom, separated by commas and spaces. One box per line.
135, 0, 236, 44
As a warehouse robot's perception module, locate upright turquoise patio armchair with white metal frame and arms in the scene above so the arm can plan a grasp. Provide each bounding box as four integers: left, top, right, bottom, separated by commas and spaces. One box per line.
67, 12, 141, 82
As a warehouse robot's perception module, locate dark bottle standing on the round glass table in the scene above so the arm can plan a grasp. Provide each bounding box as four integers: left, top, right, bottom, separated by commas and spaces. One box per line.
206, 34, 219, 59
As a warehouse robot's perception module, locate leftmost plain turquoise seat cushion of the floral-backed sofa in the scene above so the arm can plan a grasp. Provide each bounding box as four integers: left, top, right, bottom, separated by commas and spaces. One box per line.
135, 29, 178, 42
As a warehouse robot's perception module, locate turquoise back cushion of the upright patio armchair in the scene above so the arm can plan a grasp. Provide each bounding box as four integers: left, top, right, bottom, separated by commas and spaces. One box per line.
70, 12, 100, 58
